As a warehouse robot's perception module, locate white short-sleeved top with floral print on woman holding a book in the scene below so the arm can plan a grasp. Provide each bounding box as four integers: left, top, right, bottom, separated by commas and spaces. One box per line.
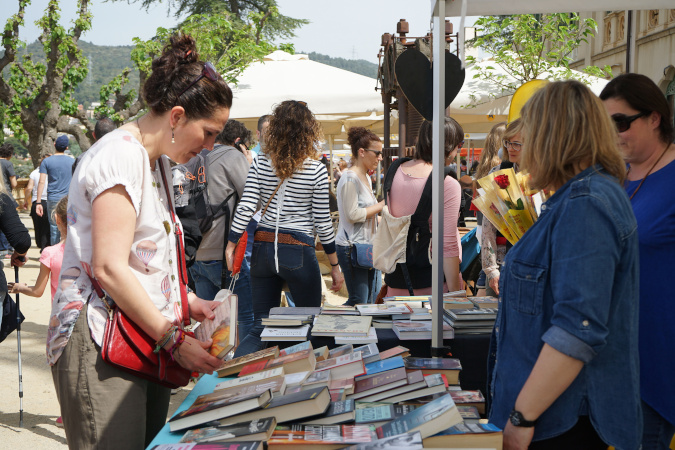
47, 130, 182, 365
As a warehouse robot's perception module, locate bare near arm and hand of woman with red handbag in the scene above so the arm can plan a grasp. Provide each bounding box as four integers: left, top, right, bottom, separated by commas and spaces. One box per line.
91, 184, 222, 373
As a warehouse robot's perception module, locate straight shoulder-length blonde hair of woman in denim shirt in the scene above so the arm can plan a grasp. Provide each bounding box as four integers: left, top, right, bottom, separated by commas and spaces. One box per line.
519, 80, 626, 189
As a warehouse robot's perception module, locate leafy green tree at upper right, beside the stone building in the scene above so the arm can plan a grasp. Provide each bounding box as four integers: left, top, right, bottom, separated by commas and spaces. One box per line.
466, 13, 611, 101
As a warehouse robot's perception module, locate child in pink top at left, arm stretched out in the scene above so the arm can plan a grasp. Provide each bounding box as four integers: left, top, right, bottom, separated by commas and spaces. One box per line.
7, 195, 68, 301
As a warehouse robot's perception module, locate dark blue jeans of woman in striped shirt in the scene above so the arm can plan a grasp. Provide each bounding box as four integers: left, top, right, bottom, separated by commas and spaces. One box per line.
234, 230, 323, 358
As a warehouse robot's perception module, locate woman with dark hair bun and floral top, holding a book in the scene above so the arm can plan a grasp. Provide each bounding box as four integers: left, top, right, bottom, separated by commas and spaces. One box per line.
47, 35, 232, 450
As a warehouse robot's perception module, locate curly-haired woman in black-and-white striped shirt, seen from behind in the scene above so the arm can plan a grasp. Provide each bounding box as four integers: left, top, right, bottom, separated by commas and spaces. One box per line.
226, 100, 344, 357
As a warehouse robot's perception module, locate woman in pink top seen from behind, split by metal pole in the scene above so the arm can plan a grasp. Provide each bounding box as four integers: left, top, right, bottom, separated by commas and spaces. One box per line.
384, 117, 464, 296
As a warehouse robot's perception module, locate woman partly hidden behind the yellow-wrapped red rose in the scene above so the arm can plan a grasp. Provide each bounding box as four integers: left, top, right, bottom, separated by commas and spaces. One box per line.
480, 119, 523, 296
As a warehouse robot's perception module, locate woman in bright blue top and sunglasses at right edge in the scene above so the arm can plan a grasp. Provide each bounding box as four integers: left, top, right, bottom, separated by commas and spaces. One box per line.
600, 73, 675, 450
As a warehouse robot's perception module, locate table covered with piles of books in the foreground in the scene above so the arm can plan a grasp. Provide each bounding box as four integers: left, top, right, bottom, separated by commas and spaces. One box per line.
148, 298, 502, 450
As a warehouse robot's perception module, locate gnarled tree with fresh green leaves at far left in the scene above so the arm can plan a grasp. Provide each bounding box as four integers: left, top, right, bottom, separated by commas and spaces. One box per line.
0, 0, 91, 164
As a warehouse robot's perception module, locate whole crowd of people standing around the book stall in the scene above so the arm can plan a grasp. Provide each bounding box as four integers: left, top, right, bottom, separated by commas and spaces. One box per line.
0, 29, 675, 449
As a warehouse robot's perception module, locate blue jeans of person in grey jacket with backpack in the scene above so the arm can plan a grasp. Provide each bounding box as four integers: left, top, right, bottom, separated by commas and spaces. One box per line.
190, 258, 253, 341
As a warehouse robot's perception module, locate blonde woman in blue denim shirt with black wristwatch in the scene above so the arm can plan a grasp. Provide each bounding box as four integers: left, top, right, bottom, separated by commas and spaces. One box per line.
489, 81, 642, 450
